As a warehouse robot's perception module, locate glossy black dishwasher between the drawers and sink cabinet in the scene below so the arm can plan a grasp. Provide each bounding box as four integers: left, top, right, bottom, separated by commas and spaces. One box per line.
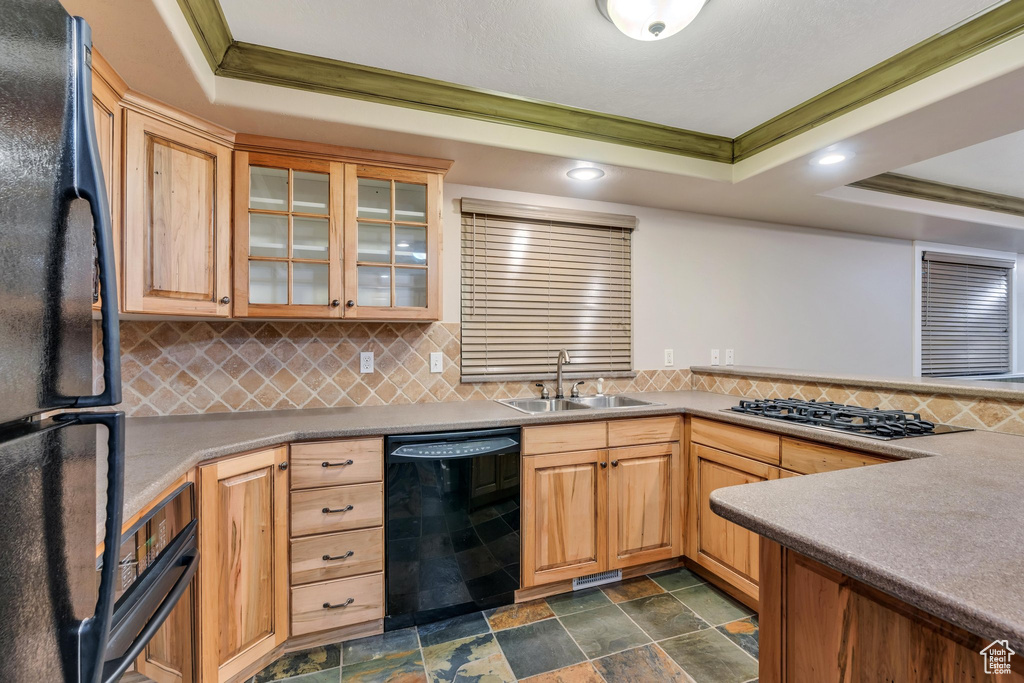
384, 427, 519, 631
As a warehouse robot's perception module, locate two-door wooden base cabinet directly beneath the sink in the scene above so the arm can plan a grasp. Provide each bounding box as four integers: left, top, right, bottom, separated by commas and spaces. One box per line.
521, 417, 684, 588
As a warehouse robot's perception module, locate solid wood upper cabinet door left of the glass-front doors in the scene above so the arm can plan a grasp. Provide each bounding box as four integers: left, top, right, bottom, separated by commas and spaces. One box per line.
122, 109, 231, 317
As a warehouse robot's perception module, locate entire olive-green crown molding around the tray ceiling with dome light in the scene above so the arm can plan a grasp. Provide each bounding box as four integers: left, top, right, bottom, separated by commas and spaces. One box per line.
178, 0, 1024, 164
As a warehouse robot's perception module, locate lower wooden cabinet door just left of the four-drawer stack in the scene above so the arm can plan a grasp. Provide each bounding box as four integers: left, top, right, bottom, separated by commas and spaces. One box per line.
199, 446, 289, 683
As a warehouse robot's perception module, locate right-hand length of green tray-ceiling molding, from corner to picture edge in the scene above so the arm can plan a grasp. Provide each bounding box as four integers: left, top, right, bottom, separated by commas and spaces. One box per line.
734, 0, 1024, 162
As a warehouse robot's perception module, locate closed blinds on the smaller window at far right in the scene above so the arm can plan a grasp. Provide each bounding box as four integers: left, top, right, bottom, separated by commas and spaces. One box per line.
921, 252, 1014, 377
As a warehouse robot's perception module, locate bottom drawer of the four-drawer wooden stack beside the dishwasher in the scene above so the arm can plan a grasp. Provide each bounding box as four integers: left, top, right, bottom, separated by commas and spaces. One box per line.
292, 573, 384, 636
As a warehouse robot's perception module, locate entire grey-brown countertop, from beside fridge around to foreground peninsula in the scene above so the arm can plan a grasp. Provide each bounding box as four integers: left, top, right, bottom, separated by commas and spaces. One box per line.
97, 391, 1024, 647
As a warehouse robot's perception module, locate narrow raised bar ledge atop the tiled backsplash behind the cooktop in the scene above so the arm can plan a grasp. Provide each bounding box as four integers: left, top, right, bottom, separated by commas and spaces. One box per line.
690, 366, 1024, 401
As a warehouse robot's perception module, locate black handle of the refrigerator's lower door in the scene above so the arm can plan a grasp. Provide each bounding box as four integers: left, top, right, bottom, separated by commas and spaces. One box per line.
70, 412, 125, 683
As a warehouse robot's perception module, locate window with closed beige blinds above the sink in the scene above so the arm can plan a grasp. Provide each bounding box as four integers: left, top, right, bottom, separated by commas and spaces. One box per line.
462, 199, 636, 382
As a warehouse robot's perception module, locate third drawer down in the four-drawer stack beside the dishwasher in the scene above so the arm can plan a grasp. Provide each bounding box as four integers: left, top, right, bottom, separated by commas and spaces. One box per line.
292, 527, 384, 586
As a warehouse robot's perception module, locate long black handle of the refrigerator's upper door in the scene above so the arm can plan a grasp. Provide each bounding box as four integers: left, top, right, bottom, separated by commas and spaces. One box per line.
68, 16, 121, 408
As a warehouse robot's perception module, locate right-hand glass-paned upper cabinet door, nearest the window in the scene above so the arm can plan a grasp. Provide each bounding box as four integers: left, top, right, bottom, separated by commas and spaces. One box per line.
344, 164, 440, 321
